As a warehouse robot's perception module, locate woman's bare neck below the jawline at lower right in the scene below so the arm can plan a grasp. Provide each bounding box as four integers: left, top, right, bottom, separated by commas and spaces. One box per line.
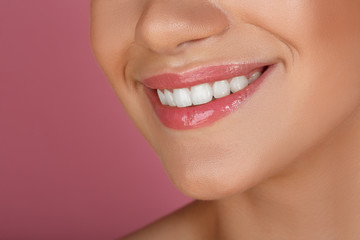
216, 109, 360, 240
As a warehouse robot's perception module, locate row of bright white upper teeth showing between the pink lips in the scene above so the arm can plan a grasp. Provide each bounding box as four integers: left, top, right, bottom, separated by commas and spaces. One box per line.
157, 72, 261, 107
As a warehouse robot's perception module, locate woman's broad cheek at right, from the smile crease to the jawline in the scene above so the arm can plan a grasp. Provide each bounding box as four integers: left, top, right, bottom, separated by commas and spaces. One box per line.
243, 0, 360, 142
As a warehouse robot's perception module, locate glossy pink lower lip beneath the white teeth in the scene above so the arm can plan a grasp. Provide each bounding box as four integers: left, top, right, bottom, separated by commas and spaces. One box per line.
146, 65, 276, 130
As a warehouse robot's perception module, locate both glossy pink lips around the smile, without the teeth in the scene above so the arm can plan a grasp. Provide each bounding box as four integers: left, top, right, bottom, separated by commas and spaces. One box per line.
144, 64, 275, 130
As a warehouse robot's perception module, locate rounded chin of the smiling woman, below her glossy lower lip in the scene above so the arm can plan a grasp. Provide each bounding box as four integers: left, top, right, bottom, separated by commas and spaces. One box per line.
153, 141, 271, 200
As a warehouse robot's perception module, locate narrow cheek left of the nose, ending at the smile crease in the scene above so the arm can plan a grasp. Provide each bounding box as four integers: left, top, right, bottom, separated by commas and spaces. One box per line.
90, 0, 144, 81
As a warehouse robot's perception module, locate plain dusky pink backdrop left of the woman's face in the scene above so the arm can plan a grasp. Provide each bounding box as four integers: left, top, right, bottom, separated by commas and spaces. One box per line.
0, 0, 190, 240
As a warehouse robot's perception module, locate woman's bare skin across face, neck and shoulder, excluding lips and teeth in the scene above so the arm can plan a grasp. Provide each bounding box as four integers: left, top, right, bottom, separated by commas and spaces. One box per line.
91, 0, 360, 240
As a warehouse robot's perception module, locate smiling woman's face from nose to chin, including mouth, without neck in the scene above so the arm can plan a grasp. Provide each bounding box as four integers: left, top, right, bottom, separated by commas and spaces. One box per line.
91, 0, 360, 199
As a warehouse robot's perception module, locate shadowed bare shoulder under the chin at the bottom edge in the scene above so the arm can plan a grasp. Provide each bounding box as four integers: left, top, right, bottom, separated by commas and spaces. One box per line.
118, 201, 215, 240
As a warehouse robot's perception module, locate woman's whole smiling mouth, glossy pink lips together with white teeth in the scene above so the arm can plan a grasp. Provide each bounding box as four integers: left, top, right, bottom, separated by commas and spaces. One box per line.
143, 63, 277, 130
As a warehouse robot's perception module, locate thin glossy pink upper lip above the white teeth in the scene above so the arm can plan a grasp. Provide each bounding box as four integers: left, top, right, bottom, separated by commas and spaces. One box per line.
142, 63, 271, 89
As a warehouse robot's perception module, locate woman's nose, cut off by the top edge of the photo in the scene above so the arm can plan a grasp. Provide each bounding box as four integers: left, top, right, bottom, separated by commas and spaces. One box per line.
135, 0, 229, 54
